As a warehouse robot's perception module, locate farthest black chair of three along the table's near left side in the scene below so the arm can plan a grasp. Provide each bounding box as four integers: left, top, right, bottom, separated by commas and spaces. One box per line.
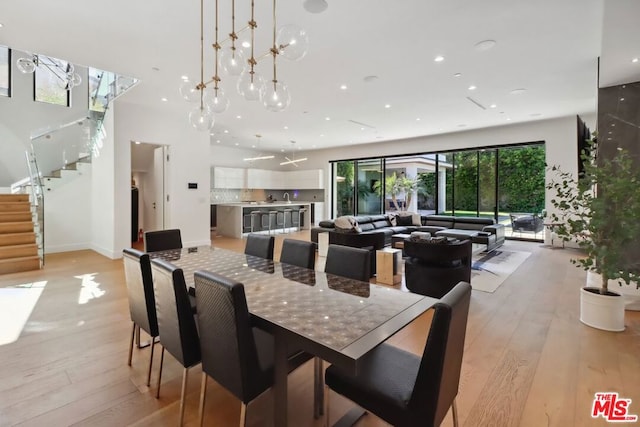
122, 249, 158, 387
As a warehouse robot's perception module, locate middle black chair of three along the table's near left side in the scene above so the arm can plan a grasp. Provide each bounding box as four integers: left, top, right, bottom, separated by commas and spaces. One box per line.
151, 259, 200, 425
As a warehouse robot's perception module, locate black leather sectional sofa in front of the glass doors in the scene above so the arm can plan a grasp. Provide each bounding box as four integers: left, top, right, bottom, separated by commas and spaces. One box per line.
311, 215, 505, 271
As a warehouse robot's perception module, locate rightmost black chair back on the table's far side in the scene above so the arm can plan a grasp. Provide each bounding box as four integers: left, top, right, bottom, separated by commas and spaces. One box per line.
324, 245, 371, 282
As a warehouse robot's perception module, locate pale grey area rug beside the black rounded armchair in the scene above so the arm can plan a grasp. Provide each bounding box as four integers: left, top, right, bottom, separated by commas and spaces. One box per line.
471, 249, 531, 292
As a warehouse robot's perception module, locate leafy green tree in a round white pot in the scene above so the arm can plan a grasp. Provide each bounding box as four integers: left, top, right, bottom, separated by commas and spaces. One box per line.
546, 138, 640, 331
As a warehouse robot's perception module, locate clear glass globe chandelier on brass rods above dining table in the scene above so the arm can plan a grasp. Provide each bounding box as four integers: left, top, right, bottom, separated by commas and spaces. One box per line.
180, 0, 308, 131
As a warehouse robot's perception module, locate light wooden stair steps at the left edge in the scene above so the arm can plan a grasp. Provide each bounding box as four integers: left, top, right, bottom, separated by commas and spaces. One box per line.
0, 194, 40, 274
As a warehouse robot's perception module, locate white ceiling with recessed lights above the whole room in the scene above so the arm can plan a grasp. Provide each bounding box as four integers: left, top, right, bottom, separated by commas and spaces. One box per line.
0, 0, 640, 154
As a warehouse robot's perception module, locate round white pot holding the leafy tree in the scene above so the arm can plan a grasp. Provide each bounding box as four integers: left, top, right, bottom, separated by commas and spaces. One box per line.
580, 287, 624, 332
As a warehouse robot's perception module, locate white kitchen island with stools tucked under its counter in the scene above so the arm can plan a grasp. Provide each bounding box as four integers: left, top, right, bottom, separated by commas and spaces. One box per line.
216, 202, 311, 238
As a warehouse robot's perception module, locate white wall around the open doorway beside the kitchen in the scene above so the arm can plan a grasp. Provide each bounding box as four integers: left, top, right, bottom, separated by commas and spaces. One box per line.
115, 102, 211, 252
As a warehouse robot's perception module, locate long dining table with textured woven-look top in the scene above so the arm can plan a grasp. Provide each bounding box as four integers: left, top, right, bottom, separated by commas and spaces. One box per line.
149, 246, 438, 427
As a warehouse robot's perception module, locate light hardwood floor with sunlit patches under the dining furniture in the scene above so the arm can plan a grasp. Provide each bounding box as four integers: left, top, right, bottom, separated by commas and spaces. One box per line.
0, 232, 640, 427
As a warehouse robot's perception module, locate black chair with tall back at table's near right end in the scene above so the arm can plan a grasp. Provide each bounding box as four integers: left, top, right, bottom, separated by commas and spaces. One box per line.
325, 282, 471, 427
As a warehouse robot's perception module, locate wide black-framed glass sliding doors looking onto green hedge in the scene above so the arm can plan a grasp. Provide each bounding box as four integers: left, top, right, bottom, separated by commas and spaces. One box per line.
333, 143, 545, 240
